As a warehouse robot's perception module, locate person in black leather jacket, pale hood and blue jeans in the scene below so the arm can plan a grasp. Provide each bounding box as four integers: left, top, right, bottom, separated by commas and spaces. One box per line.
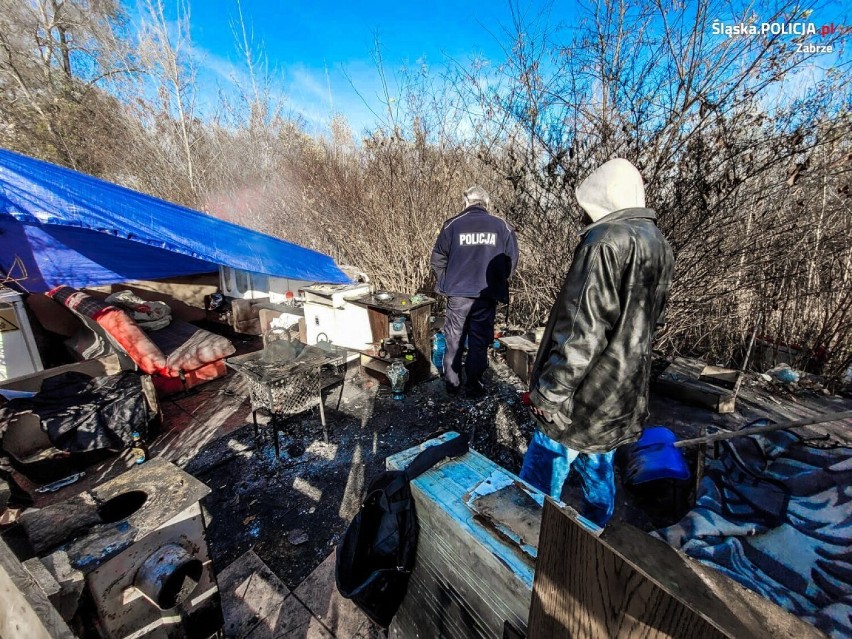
521, 159, 674, 526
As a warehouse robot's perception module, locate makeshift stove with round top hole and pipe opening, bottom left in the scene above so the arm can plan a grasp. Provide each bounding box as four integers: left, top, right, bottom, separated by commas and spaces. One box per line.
21, 459, 222, 639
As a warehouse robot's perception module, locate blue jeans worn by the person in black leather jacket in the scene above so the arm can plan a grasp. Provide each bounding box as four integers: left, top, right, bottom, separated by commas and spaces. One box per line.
520, 430, 615, 527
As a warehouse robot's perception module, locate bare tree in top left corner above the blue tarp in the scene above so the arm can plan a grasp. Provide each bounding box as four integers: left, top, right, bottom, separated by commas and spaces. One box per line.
0, 0, 134, 173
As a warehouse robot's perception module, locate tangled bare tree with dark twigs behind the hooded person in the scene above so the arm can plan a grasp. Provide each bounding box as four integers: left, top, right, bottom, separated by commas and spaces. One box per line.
457, 0, 850, 380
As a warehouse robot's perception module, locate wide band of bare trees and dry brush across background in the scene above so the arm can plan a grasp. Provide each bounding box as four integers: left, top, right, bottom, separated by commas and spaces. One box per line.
0, 0, 852, 382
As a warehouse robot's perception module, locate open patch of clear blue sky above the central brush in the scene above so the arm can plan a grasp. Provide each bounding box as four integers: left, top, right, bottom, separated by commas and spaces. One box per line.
157, 0, 573, 132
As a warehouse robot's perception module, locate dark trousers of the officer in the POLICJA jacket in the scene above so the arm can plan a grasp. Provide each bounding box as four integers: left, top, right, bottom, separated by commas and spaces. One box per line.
444, 297, 497, 386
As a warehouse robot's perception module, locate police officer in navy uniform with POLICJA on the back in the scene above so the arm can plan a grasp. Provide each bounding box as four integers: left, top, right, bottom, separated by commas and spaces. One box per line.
431, 186, 518, 396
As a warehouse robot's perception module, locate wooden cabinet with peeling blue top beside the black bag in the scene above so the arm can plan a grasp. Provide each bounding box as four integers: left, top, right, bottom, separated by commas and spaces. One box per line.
387, 433, 535, 639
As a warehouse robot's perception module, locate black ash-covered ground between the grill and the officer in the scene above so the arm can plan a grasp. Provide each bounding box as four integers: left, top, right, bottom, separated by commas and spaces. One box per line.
186, 355, 534, 588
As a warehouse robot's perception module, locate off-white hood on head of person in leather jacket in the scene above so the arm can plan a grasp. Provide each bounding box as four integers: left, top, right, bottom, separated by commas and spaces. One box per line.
574, 158, 645, 222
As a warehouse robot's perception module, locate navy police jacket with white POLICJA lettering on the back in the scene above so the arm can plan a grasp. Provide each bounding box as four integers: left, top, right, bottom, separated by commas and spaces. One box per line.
431, 205, 518, 302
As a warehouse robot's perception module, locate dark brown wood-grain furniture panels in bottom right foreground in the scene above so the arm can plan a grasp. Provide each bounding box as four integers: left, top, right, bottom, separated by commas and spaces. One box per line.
528, 498, 824, 639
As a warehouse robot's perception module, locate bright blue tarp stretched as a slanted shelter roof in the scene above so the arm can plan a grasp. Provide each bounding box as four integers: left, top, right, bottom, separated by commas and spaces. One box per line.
0, 149, 349, 292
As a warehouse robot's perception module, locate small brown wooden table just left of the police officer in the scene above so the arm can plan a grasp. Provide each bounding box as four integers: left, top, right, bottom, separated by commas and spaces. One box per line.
350, 292, 435, 384
